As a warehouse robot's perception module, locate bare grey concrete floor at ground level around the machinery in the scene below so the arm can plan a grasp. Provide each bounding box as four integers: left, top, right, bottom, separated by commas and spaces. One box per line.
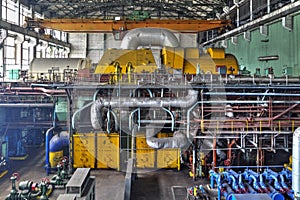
0, 147, 209, 200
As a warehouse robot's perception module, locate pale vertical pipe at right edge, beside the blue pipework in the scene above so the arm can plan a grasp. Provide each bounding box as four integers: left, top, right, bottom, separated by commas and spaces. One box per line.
292, 127, 300, 198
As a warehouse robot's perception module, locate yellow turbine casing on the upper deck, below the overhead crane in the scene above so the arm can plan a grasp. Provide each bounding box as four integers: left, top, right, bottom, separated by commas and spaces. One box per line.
95, 47, 239, 81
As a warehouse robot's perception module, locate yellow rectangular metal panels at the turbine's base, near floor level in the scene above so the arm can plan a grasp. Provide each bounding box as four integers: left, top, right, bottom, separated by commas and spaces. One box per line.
73, 133, 180, 170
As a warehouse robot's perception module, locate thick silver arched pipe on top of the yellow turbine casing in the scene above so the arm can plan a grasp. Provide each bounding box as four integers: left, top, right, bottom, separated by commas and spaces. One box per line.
120, 28, 179, 49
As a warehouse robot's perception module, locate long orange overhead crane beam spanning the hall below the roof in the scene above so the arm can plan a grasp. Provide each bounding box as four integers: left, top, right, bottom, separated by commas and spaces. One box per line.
26, 18, 230, 33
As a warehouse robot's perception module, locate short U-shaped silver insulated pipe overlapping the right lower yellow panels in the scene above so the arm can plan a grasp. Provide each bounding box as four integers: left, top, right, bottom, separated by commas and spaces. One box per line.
146, 124, 188, 149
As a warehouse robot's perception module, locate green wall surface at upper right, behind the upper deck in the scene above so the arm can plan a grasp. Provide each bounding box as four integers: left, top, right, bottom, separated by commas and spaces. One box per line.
226, 15, 300, 76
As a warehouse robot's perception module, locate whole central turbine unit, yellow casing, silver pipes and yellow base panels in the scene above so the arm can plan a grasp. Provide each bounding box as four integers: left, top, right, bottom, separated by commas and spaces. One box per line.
72, 29, 239, 170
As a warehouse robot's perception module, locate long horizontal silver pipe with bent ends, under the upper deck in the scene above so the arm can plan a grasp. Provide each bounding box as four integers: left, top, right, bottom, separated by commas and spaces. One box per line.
91, 90, 198, 129
